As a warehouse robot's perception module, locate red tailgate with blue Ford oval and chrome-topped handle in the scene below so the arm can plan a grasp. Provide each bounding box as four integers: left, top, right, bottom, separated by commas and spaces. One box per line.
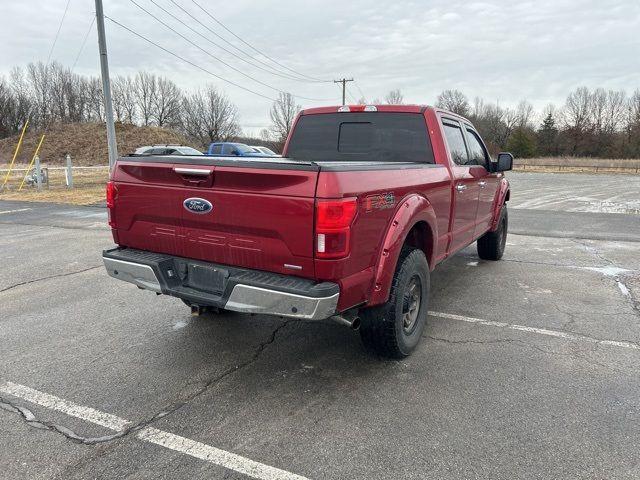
112, 157, 318, 278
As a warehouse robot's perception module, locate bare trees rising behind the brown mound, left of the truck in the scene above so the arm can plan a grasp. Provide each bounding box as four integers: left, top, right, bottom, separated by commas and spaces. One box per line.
0, 62, 249, 147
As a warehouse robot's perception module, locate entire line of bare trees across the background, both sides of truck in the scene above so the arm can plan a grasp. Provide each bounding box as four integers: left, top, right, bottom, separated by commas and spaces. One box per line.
0, 62, 640, 158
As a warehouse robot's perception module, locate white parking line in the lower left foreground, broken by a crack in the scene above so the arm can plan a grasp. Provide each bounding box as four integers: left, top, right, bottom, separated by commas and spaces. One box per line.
0, 381, 308, 480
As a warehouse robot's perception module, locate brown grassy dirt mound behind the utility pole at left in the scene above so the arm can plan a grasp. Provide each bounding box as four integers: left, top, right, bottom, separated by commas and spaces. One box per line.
0, 123, 189, 168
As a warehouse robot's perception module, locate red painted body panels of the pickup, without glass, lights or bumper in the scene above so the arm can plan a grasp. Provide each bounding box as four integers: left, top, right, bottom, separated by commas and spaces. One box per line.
110, 105, 509, 311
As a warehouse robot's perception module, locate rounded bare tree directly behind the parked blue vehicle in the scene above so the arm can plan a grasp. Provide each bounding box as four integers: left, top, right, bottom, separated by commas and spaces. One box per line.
182, 85, 241, 147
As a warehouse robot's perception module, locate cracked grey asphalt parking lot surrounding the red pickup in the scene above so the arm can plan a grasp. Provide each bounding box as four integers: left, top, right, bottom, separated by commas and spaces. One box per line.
0, 173, 640, 479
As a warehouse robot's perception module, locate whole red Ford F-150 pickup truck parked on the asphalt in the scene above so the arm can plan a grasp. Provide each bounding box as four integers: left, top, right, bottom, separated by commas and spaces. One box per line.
103, 105, 513, 358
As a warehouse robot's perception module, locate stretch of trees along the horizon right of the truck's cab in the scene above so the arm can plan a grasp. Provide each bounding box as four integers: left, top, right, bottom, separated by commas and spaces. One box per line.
436, 87, 640, 158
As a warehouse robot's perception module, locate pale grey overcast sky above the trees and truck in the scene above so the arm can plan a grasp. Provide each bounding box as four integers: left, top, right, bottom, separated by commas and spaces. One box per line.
0, 0, 640, 133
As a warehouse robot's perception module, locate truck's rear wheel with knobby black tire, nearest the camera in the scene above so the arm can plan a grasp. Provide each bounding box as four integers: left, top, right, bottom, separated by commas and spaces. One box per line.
360, 247, 430, 358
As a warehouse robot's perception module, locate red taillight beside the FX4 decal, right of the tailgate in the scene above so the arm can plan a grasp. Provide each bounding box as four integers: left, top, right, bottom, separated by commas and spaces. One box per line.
316, 198, 358, 258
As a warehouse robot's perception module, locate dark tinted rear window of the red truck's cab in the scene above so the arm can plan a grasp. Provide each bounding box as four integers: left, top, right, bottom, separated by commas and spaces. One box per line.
287, 112, 435, 163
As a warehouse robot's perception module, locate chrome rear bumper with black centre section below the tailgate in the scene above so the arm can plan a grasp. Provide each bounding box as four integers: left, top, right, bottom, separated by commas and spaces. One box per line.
102, 248, 340, 320
